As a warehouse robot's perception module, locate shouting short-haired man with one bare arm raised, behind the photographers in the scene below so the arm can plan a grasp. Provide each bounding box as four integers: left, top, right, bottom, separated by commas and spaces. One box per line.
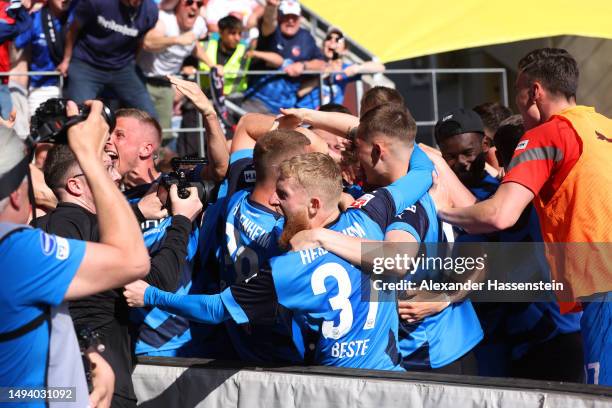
101, 77, 229, 356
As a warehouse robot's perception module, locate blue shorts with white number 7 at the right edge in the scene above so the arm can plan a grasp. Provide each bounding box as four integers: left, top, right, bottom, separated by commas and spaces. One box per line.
580, 292, 612, 385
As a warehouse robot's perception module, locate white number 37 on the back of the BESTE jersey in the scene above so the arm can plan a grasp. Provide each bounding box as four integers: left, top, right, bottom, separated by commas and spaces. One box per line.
310, 263, 378, 340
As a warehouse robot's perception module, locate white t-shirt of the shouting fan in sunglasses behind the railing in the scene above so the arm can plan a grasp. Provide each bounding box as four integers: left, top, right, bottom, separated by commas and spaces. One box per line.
138, 10, 208, 77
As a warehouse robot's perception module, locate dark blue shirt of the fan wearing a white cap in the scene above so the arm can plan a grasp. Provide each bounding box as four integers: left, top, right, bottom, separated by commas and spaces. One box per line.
245, 27, 324, 113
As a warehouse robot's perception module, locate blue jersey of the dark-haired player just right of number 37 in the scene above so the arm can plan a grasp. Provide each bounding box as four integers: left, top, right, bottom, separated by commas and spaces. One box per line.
387, 194, 483, 370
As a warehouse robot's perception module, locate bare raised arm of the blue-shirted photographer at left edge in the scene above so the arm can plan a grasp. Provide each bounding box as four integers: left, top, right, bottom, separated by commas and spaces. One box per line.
64, 101, 150, 300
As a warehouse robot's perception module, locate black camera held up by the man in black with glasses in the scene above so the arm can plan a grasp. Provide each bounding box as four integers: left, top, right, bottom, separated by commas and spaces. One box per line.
159, 157, 215, 208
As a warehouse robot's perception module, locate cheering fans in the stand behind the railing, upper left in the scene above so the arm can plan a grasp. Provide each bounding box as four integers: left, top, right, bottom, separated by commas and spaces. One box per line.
0, 0, 384, 145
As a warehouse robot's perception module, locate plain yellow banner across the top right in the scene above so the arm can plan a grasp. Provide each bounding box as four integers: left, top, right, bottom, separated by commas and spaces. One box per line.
302, 0, 612, 62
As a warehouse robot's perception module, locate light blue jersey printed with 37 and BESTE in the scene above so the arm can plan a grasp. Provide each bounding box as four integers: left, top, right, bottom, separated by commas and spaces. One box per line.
221, 210, 400, 370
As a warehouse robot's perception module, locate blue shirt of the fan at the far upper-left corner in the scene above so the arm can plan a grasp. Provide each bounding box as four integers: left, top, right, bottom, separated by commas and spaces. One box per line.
15, 6, 74, 88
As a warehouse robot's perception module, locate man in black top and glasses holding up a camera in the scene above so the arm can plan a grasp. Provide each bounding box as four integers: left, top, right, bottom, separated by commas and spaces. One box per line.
37, 145, 202, 407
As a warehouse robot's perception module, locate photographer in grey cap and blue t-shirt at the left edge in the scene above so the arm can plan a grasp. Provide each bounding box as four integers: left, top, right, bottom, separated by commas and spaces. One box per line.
0, 101, 149, 407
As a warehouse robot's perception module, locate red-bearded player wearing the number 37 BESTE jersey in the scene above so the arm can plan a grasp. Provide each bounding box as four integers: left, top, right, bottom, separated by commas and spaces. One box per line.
124, 152, 430, 371
